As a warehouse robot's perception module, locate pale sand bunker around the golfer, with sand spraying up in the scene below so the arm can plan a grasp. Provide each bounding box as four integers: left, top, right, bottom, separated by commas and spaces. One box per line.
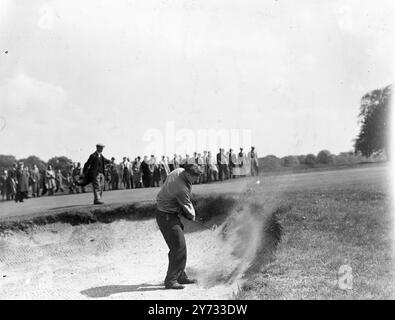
0, 195, 281, 299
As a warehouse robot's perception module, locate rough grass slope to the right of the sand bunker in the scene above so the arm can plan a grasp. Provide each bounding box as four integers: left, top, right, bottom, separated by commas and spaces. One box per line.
237, 165, 395, 299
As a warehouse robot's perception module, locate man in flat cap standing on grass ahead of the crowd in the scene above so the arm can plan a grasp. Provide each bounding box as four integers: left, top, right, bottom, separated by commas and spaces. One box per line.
79, 143, 111, 204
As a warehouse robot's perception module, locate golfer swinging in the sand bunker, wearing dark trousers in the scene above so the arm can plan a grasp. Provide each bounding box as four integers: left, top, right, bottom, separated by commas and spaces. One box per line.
156, 164, 202, 289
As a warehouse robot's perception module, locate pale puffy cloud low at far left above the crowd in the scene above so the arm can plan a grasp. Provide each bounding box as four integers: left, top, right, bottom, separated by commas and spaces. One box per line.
0, 73, 94, 159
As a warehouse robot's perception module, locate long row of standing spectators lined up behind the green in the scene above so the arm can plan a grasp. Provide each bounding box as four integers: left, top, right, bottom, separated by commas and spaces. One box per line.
0, 147, 259, 202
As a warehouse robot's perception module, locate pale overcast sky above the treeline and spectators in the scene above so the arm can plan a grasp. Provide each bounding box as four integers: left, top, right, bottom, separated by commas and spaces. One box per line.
0, 0, 395, 161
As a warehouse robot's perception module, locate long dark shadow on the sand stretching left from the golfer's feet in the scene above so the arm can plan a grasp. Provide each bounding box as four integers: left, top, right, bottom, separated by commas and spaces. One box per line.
81, 283, 166, 298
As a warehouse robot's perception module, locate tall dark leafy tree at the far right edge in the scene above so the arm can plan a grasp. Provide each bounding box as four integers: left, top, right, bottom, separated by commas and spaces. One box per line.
354, 85, 392, 157
